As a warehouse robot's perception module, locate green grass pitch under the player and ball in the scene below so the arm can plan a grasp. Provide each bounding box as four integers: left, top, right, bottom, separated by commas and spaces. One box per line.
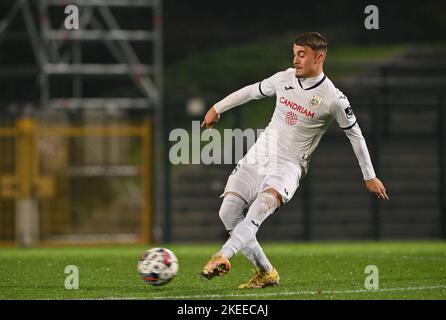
0, 241, 446, 300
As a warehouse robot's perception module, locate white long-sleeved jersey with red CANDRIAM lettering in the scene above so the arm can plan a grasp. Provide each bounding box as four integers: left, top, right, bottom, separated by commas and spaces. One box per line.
214, 68, 376, 180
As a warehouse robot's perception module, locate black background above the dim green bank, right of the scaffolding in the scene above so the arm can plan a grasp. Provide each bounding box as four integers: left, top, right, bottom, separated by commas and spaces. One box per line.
163, 0, 446, 65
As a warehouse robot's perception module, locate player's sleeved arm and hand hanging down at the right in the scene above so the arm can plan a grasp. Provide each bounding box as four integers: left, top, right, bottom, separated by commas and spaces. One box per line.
330, 93, 389, 200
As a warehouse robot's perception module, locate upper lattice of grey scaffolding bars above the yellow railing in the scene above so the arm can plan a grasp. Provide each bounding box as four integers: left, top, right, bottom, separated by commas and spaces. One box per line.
39, 0, 162, 109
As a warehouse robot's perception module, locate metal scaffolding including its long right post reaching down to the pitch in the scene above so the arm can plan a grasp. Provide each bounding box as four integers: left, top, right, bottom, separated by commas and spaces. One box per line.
40, 0, 166, 241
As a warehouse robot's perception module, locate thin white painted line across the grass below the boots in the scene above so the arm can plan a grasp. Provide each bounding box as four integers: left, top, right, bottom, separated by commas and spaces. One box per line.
153, 286, 446, 300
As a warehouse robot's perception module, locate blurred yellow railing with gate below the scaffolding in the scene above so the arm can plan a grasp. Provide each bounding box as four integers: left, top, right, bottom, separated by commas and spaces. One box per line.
0, 118, 152, 246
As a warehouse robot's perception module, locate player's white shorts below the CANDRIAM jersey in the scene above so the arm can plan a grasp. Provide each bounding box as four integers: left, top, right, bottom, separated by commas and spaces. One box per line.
221, 157, 308, 205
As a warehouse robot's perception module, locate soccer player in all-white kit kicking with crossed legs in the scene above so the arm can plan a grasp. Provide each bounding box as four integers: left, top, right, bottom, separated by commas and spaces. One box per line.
201, 32, 389, 288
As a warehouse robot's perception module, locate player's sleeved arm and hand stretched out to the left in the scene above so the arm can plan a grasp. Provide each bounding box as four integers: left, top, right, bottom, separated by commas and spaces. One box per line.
201, 72, 280, 129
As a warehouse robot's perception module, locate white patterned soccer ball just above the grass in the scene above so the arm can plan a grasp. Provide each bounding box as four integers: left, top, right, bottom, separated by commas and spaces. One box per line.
138, 248, 179, 286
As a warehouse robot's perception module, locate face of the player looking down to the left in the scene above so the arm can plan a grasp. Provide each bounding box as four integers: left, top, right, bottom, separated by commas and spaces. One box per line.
293, 45, 322, 78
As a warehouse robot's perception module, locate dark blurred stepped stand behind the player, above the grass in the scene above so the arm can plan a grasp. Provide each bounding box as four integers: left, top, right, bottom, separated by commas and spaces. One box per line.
172, 48, 446, 241
